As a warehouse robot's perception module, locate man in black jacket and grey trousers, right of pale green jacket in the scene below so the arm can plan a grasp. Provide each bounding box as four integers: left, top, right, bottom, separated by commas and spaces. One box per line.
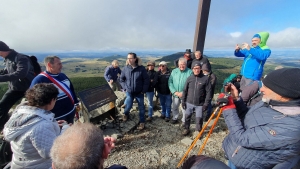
182, 62, 211, 135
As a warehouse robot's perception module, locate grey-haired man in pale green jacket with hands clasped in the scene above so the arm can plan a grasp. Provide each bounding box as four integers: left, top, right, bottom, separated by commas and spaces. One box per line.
168, 58, 193, 124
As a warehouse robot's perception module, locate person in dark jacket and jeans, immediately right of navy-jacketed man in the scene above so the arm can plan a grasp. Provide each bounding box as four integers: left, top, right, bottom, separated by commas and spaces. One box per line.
146, 62, 157, 121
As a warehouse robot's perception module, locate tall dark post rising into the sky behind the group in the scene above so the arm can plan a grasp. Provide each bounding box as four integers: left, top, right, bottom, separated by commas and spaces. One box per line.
193, 0, 211, 53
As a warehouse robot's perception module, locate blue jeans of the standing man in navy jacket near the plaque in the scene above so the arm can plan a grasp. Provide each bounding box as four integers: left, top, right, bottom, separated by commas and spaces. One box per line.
124, 92, 145, 123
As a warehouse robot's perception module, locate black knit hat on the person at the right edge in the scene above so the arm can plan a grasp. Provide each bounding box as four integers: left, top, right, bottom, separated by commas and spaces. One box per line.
262, 68, 300, 99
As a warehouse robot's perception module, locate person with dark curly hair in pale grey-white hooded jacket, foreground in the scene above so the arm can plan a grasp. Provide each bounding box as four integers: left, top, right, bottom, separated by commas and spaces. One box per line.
3, 83, 68, 169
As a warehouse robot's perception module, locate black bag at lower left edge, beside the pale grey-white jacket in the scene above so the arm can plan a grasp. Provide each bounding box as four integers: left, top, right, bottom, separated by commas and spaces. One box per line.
0, 136, 12, 168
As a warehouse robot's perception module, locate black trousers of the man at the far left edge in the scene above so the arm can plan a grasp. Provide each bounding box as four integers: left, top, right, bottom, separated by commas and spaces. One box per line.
0, 90, 25, 131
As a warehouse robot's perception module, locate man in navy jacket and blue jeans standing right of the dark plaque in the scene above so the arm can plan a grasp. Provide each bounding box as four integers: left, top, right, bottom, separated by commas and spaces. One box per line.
120, 53, 150, 130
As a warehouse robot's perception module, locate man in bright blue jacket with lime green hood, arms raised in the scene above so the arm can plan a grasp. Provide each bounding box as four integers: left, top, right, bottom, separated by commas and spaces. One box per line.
234, 32, 271, 90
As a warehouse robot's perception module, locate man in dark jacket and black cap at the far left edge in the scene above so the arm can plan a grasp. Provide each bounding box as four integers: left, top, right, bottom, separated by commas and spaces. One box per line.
0, 41, 34, 131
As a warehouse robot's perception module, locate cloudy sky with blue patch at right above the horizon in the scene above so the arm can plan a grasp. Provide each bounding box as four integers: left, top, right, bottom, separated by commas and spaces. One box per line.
0, 0, 300, 51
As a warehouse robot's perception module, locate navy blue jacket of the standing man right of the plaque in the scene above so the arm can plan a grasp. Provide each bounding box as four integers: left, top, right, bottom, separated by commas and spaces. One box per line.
120, 65, 150, 94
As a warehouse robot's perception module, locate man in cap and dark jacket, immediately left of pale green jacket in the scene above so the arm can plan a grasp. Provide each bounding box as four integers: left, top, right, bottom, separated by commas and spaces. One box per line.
156, 61, 172, 122
